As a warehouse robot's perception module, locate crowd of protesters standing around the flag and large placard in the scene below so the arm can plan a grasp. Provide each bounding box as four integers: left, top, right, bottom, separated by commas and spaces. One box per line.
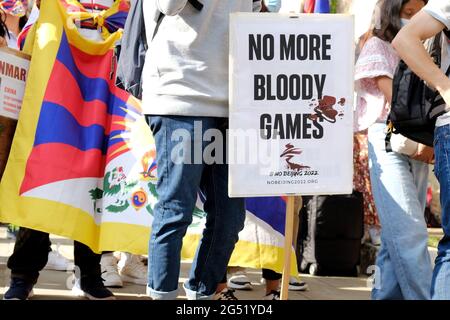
0, 0, 450, 300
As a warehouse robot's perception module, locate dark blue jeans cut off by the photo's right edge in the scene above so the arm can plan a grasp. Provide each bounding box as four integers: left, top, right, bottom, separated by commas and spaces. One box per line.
431, 125, 450, 300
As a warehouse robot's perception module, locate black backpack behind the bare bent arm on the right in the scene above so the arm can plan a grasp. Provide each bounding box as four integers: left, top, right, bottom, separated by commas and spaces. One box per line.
386, 33, 450, 148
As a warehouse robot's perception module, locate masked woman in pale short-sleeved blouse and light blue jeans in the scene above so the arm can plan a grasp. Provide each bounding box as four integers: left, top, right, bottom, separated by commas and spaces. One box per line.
356, 0, 431, 299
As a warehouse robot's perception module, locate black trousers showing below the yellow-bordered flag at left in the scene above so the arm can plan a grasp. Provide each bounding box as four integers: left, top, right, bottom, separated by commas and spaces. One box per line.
8, 227, 101, 283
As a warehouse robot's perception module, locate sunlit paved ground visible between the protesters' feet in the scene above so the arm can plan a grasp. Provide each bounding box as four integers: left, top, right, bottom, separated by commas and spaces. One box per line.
0, 227, 370, 300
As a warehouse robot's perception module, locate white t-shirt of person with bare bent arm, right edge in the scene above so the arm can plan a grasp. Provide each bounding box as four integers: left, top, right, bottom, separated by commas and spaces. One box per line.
423, 0, 450, 127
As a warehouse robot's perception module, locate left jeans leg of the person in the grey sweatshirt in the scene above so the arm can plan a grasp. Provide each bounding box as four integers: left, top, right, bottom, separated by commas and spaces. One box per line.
148, 116, 205, 300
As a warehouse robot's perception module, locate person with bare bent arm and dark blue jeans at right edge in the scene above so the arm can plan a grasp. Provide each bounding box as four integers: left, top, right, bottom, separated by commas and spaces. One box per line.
393, 0, 450, 300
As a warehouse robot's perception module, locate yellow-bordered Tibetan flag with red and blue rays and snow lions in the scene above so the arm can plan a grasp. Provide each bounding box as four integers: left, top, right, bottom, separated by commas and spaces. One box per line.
0, 0, 297, 274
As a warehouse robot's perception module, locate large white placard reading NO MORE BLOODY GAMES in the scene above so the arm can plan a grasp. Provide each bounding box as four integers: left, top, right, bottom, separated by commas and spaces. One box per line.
228, 13, 355, 197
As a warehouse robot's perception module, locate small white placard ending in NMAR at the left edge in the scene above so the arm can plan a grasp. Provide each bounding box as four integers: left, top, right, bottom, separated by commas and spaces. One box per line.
0, 48, 30, 120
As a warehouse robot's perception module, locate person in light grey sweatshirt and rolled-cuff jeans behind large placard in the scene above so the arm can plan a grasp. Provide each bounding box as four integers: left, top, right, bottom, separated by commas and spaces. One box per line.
143, 0, 261, 299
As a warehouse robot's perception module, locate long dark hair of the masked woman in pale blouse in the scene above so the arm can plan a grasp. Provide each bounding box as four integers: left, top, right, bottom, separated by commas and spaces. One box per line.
372, 0, 428, 42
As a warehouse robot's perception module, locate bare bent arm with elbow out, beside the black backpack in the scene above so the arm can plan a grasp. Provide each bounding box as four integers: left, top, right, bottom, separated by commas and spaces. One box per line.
392, 11, 450, 105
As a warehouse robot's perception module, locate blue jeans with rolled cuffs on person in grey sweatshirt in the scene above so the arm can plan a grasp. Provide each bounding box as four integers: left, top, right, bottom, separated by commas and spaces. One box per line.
147, 116, 245, 300
